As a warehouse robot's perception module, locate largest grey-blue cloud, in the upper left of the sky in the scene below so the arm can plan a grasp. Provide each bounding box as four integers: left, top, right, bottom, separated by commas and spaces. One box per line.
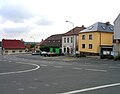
0, 4, 34, 22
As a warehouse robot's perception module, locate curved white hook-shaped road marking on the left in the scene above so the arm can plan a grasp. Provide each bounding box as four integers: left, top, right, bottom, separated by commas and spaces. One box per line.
0, 62, 40, 75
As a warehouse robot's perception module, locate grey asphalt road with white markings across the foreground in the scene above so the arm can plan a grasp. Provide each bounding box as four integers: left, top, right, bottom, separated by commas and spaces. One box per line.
0, 55, 120, 94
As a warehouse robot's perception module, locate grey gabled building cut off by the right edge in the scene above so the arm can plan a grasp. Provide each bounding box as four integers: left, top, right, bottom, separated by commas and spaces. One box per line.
114, 14, 120, 55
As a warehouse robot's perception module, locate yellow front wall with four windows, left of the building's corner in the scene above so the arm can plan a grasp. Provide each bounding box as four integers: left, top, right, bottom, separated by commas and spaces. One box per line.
78, 32, 100, 53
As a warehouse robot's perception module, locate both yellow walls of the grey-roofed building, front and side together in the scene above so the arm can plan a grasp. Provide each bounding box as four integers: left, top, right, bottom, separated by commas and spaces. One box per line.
78, 32, 113, 53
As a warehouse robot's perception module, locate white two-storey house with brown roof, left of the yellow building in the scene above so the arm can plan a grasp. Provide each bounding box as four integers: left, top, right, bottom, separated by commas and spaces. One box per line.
62, 26, 85, 54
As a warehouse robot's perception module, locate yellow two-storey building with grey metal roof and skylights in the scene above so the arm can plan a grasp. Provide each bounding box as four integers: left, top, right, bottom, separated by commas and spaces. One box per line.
78, 22, 113, 55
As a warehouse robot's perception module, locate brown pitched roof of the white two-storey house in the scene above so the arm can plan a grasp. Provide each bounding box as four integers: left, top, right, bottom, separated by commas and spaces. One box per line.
63, 26, 85, 36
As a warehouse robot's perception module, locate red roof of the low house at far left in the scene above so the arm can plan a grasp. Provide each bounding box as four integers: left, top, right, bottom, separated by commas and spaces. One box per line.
2, 39, 25, 49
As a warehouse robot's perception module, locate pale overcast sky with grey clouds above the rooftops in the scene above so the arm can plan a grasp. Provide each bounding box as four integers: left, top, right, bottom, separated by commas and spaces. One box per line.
0, 0, 120, 42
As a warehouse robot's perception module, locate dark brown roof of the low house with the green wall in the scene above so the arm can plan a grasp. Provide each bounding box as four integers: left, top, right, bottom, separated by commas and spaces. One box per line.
41, 34, 63, 47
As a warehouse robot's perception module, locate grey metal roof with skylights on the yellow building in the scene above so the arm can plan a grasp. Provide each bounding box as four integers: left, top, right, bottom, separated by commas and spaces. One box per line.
80, 22, 114, 33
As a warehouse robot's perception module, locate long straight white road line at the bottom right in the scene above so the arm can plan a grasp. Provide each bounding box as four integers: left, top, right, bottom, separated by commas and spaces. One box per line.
56, 83, 120, 94
